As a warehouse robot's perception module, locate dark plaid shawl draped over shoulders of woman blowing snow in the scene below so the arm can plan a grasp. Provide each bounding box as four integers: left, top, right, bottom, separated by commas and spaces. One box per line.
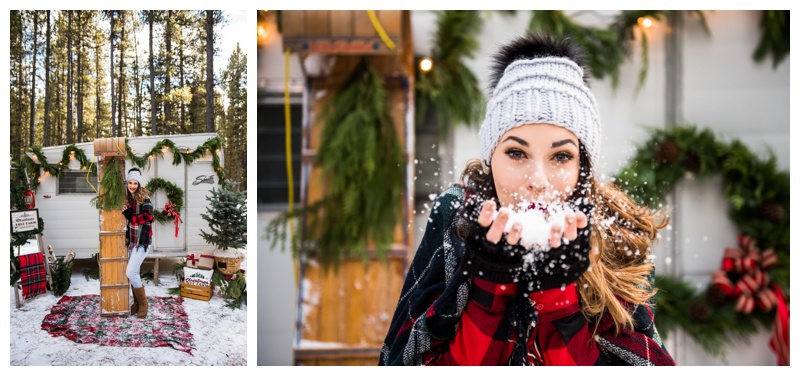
378, 186, 674, 365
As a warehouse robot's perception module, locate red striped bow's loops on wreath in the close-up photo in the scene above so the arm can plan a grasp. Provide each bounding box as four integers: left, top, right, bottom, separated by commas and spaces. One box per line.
713, 235, 778, 314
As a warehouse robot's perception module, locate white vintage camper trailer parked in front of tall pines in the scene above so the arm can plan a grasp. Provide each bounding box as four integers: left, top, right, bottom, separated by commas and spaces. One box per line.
30, 133, 224, 258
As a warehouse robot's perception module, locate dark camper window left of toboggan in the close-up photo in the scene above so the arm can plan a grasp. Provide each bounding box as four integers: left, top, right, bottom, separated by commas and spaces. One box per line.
256, 93, 303, 210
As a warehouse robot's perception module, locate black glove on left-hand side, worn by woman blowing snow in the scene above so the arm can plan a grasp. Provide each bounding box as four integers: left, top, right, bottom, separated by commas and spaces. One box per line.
461, 202, 526, 283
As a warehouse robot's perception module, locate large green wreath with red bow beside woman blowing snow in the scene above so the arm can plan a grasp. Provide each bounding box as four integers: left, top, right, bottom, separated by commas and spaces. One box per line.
615, 126, 790, 365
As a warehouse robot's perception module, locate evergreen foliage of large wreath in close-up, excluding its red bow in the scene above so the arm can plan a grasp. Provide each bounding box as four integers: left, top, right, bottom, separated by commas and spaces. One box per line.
615, 126, 790, 356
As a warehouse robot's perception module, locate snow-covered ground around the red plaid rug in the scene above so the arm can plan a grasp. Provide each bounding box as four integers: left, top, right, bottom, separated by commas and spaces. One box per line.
9, 260, 247, 366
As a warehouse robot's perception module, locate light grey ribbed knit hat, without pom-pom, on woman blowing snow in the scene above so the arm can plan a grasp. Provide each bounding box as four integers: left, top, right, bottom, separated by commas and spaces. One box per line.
479, 57, 600, 166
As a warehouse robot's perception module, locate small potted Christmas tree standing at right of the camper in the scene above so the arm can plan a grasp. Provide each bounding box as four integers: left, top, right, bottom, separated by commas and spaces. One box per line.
200, 183, 247, 275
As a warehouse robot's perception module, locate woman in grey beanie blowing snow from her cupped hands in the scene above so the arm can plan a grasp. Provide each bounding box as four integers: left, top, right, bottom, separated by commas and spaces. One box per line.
379, 34, 675, 365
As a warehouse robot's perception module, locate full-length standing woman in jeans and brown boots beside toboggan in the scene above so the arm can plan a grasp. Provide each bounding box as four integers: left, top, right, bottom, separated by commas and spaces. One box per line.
122, 167, 153, 319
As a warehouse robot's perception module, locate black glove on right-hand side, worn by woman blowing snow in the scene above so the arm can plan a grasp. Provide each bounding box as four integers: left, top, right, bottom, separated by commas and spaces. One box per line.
520, 204, 594, 292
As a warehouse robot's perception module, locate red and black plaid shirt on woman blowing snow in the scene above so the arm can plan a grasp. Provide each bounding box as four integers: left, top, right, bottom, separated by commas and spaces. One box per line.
427, 278, 675, 366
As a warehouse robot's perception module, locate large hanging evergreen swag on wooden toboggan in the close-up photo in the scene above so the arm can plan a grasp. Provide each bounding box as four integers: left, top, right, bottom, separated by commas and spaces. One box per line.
266, 58, 405, 271
